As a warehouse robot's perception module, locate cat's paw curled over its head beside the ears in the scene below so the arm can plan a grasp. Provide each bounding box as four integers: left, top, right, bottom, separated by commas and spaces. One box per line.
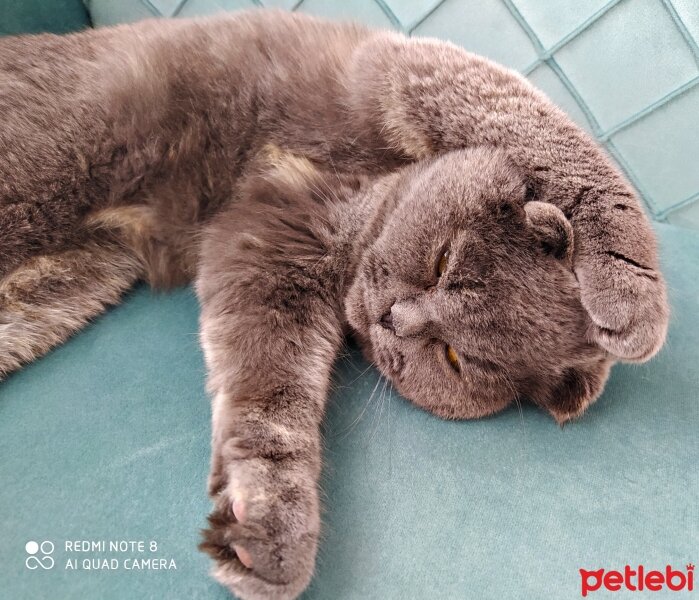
575, 253, 669, 362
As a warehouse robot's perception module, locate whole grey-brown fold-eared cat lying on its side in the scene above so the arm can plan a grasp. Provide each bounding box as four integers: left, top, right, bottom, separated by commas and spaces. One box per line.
0, 10, 668, 599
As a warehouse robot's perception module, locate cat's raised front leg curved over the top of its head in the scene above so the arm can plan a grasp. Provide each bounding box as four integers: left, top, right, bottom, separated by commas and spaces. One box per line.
347, 33, 669, 361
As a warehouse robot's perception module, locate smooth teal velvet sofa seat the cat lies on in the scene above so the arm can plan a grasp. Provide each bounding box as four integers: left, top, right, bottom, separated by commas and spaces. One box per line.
0, 225, 699, 600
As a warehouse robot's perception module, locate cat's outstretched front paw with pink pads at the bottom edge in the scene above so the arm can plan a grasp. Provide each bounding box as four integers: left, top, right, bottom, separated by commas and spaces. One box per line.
200, 438, 320, 600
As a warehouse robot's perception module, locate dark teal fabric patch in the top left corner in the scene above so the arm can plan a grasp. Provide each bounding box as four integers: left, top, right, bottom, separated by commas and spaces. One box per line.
0, 0, 90, 35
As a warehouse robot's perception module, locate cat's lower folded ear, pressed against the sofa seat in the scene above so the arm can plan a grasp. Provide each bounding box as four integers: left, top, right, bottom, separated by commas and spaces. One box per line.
531, 357, 613, 425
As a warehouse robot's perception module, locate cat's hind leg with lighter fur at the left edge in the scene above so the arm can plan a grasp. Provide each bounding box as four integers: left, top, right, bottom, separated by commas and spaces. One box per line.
0, 235, 143, 380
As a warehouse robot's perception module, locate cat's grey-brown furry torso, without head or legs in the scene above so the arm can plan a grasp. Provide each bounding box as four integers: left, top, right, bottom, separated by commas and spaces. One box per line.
0, 13, 394, 286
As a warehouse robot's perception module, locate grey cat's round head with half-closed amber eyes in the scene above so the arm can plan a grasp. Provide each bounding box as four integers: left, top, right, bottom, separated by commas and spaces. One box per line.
345, 149, 611, 423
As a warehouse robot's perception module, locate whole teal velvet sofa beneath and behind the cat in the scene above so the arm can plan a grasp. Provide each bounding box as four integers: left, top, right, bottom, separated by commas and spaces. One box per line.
0, 0, 699, 600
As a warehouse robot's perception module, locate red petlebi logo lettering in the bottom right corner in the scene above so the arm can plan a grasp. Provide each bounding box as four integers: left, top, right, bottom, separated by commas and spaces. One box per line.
580, 563, 694, 598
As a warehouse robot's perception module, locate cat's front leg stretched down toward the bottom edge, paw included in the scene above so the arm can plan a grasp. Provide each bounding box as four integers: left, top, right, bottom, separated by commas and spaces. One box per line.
197, 190, 342, 600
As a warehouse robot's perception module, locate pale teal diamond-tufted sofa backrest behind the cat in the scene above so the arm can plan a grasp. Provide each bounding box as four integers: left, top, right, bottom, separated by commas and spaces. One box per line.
87, 0, 699, 228
